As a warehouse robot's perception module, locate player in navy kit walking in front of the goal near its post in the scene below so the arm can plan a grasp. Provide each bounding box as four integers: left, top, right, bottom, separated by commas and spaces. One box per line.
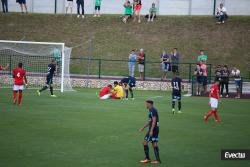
37, 59, 56, 97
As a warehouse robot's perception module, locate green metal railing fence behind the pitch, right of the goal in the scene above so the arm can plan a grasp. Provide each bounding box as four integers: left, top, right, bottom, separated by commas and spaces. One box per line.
70, 58, 212, 82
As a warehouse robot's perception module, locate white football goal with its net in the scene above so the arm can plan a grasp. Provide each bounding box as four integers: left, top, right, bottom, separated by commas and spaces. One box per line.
0, 40, 73, 92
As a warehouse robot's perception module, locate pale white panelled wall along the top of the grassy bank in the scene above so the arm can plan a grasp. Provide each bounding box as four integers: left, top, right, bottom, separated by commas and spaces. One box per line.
0, 0, 250, 15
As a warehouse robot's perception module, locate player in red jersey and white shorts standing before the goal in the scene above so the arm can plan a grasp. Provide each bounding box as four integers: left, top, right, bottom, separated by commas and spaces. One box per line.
12, 63, 28, 106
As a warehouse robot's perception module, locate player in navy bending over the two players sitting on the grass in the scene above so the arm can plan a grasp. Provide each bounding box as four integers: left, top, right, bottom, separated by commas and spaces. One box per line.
121, 76, 136, 100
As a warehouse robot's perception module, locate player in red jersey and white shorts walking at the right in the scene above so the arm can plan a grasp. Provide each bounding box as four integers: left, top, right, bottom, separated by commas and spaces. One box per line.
204, 81, 220, 123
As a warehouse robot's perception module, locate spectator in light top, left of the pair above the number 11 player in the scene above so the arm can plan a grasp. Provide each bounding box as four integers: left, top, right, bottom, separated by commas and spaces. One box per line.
161, 50, 170, 81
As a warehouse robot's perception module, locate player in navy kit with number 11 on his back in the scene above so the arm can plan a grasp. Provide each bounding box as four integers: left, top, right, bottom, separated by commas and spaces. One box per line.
171, 72, 182, 114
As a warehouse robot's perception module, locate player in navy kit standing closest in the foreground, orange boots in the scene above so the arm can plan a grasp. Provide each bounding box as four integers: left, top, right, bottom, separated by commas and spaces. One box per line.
139, 100, 161, 164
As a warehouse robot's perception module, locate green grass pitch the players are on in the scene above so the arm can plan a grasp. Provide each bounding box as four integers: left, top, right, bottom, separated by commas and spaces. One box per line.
0, 89, 250, 167
